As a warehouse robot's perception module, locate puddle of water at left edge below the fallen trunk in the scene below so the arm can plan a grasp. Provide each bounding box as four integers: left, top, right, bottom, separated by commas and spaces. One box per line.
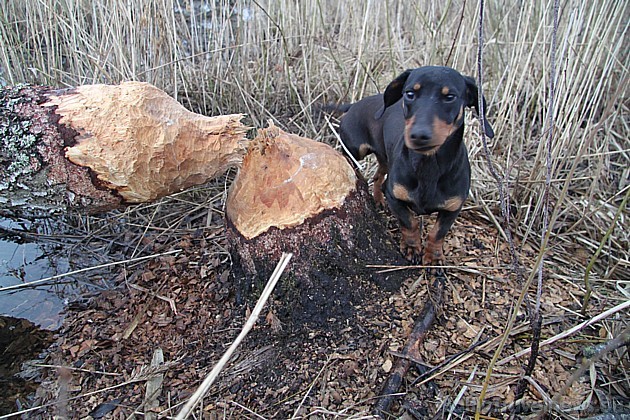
0, 218, 117, 416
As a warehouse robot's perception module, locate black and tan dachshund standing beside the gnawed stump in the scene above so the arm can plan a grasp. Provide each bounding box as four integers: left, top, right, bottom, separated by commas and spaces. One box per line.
338, 66, 494, 265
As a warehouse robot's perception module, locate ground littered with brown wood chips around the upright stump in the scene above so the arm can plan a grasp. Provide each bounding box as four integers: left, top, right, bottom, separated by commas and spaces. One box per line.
8, 205, 630, 419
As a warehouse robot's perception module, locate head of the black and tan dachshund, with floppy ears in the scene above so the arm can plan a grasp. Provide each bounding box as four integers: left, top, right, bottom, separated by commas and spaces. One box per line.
375, 66, 494, 154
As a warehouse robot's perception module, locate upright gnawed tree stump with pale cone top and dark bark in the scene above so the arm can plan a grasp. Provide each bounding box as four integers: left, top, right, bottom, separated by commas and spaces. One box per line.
226, 126, 404, 324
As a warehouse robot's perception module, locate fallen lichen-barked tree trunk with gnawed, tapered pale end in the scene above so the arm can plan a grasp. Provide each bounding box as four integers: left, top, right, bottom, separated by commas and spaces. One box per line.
0, 82, 246, 214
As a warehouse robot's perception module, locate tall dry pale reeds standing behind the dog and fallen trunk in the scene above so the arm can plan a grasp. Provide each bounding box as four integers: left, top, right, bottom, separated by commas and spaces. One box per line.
0, 0, 630, 416
